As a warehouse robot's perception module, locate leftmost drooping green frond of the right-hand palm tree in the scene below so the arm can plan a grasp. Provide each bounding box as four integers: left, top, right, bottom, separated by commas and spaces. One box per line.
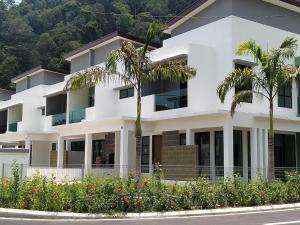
217, 68, 255, 103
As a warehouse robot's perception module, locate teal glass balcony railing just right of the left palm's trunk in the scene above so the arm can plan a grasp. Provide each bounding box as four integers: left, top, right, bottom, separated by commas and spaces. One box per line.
155, 88, 187, 111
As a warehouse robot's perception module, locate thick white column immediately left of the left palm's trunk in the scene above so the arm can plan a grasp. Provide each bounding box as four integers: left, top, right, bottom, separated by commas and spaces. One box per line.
120, 126, 129, 177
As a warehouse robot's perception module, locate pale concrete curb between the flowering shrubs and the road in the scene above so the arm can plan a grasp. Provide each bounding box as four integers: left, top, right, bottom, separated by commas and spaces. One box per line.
0, 203, 300, 220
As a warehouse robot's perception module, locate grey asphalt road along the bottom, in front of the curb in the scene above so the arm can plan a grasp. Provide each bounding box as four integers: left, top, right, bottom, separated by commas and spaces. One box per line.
0, 209, 300, 225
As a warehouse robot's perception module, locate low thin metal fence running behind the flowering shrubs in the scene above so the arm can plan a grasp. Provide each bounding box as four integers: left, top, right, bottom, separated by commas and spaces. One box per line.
0, 164, 300, 182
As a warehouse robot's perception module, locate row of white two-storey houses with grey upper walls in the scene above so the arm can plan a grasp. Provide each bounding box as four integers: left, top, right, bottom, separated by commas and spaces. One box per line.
0, 0, 300, 179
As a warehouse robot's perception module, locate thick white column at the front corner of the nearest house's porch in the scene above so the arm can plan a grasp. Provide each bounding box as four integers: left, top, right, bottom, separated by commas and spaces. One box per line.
223, 118, 234, 178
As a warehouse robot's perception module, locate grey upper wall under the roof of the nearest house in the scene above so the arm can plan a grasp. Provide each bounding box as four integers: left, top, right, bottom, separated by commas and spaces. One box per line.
172, 0, 300, 36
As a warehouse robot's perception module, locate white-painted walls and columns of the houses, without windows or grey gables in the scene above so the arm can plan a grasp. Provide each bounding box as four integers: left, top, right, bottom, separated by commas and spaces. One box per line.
0, 0, 300, 178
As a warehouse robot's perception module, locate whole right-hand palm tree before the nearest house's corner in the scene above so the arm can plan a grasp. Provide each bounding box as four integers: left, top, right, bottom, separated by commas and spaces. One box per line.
217, 37, 299, 180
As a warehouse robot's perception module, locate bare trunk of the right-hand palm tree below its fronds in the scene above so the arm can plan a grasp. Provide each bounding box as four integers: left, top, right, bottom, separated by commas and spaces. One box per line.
268, 101, 275, 181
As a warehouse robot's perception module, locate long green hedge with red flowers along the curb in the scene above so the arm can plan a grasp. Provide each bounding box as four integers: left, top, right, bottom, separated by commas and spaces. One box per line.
0, 171, 300, 213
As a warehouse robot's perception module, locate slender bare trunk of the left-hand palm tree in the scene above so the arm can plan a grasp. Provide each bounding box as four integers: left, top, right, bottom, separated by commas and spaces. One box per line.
135, 82, 142, 175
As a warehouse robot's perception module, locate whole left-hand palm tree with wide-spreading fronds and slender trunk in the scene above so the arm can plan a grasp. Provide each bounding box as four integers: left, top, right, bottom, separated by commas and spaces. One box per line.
66, 22, 196, 174
